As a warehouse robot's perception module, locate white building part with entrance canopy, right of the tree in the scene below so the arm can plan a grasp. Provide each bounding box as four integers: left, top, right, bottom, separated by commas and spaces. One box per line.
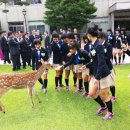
91, 0, 130, 31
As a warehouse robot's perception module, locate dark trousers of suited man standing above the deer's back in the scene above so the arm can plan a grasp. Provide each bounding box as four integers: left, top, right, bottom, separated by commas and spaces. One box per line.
11, 54, 20, 70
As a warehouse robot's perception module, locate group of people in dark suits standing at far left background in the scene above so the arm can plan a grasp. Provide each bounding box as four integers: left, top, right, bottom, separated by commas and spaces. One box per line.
0, 30, 42, 71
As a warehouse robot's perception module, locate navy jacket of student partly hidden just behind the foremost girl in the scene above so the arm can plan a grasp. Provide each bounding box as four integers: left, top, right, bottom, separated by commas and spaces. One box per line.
103, 42, 113, 70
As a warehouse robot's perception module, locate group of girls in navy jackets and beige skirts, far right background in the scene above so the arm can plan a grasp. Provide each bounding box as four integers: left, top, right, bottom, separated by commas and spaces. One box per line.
106, 28, 130, 65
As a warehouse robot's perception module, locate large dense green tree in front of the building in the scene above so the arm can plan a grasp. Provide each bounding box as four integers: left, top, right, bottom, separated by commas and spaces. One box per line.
44, 0, 97, 29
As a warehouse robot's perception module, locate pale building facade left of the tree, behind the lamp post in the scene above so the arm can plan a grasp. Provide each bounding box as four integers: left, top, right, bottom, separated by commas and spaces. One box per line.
0, 0, 49, 33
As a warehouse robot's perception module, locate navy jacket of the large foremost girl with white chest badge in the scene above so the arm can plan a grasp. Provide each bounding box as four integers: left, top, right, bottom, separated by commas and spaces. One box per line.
86, 40, 110, 80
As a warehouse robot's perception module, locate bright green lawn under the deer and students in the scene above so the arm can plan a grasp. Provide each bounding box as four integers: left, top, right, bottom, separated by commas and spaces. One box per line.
0, 65, 130, 130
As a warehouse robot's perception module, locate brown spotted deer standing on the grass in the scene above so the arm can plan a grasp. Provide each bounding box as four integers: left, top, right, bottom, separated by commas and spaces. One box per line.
0, 63, 47, 113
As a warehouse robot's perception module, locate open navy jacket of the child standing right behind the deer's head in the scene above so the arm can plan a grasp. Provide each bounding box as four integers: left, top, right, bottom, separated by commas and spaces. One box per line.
32, 47, 48, 70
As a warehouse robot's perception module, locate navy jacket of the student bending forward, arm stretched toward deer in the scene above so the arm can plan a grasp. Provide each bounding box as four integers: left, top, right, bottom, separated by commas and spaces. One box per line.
64, 50, 90, 68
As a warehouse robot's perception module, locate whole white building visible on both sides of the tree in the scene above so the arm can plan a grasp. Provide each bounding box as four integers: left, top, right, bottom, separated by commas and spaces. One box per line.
0, 0, 130, 32
